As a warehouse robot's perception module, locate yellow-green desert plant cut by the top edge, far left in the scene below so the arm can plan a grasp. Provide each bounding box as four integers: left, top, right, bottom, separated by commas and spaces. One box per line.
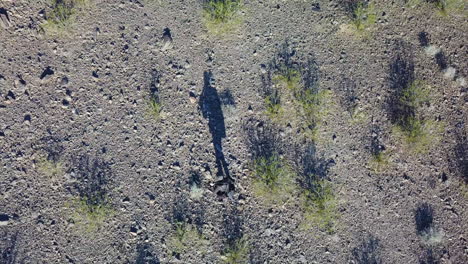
41, 0, 88, 34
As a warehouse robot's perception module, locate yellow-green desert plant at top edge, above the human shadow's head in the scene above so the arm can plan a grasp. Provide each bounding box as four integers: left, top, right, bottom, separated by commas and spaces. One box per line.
203, 0, 242, 35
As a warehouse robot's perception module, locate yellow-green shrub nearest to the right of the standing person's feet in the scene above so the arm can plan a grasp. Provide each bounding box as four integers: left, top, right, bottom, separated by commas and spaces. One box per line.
253, 155, 294, 203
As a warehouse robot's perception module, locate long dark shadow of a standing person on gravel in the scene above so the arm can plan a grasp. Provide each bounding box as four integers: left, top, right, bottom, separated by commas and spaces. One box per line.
199, 71, 234, 196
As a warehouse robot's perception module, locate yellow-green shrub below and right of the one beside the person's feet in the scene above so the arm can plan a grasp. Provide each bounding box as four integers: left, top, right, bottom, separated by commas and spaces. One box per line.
302, 179, 339, 233
